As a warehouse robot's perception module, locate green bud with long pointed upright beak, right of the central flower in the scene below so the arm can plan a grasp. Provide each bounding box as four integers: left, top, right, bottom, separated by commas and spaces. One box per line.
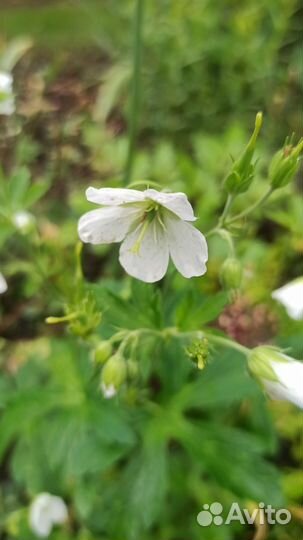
224, 112, 263, 194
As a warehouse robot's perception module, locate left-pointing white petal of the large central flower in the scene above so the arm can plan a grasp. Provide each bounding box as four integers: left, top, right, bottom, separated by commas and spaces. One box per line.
78, 206, 141, 244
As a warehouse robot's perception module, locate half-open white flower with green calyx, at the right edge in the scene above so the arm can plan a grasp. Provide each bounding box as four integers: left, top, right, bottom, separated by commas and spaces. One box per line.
248, 346, 303, 409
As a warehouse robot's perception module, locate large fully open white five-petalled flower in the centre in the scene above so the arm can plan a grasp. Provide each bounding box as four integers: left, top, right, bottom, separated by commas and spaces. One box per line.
78, 187, 208, 283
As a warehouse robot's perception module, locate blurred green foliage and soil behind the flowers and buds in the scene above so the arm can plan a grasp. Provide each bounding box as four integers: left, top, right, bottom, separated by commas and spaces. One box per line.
0, 0, 303, 540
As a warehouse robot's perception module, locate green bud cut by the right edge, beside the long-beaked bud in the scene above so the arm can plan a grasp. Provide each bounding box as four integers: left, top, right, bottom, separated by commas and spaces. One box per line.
269, 139, 303, 189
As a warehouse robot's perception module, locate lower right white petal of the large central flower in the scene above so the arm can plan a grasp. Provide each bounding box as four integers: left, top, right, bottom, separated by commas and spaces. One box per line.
164, 215, 208, 278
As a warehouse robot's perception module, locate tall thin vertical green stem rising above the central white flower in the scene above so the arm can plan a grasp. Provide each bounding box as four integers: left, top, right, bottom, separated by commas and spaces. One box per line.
124, 0, 144, 186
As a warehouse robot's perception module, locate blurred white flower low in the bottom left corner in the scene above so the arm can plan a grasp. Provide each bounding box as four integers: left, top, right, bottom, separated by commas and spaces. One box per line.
29, 493, 68, 538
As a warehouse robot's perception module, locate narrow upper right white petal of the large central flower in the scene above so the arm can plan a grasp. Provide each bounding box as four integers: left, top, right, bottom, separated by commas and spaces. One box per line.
144, 189, 197, 221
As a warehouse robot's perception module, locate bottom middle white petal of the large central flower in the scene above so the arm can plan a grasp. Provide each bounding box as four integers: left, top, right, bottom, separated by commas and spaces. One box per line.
119, 219, 169, 283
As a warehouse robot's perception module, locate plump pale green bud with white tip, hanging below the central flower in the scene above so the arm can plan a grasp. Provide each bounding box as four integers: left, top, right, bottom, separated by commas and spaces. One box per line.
101, 353, 127, 398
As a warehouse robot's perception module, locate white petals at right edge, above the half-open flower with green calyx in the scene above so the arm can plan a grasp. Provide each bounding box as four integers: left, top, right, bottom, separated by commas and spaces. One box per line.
272, 277, 303, 321
